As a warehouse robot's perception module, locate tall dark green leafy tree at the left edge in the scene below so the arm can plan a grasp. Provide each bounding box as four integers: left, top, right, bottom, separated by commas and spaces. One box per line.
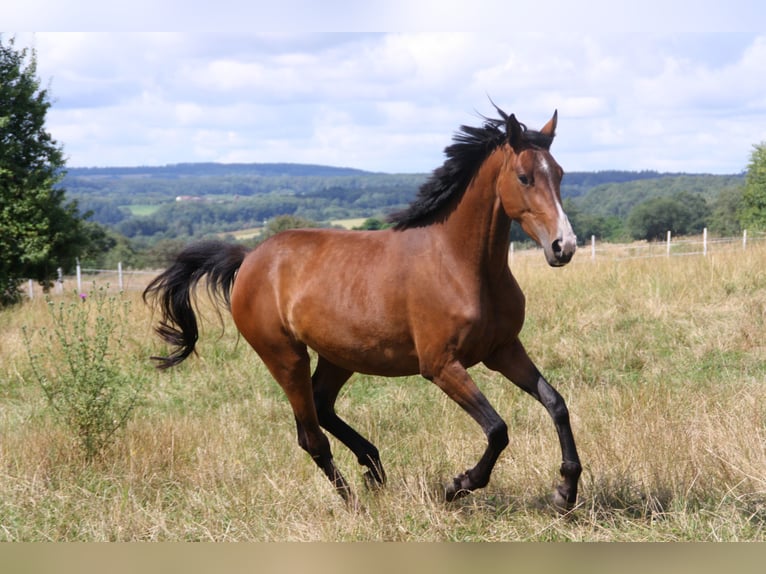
0, 36, 98, 307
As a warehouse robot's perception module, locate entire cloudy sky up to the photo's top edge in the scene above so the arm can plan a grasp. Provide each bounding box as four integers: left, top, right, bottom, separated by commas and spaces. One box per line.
3, 0, 766, 173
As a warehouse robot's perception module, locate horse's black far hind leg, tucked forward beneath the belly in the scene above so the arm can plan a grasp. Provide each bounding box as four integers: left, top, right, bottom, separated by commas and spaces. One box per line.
311, 356, 386, 488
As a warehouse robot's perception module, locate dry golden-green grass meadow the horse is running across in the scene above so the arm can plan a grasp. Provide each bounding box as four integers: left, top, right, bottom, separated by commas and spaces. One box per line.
0, 245, 766, 541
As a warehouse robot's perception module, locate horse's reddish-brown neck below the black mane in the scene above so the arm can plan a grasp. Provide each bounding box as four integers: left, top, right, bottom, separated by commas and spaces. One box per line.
443, 149, 511, 274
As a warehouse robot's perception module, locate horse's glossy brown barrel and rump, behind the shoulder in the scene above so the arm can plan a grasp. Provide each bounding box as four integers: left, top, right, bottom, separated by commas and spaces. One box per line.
233, 230, 419, 376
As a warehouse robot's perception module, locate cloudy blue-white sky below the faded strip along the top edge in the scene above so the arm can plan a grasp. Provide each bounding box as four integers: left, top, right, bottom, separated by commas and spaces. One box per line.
7, 28, 766, 172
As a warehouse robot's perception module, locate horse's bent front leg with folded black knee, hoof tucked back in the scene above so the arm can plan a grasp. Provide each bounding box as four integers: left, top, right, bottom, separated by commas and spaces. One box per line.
426, 361, 508, 501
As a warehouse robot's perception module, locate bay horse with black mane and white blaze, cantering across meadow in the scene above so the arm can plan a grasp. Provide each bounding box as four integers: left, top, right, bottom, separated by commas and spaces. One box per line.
143, 103, 581, 511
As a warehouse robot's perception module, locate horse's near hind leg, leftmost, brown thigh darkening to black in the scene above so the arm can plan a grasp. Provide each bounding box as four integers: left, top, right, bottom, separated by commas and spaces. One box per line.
261, 345, 356, 505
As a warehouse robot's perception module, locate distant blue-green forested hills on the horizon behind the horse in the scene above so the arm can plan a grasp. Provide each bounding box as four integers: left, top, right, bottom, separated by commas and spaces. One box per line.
62, 163, 744, 250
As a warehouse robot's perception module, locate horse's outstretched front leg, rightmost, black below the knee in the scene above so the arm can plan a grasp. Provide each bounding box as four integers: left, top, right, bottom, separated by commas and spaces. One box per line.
484, 339, 582, 512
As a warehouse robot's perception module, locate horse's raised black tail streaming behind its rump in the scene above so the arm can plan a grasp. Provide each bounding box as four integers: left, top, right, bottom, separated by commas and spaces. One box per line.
143, 241, 248, 369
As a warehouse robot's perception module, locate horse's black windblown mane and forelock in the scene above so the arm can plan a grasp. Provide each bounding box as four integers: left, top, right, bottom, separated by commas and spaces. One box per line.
388, 104, 553, 231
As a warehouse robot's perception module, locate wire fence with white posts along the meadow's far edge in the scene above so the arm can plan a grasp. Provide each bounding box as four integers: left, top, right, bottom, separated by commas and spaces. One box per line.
22, 229, 766, 299
